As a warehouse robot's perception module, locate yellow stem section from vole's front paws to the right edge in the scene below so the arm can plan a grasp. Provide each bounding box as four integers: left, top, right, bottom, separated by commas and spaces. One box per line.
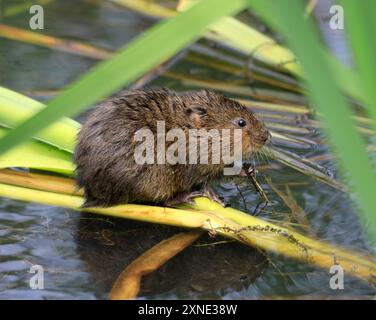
194, 198, 376, 281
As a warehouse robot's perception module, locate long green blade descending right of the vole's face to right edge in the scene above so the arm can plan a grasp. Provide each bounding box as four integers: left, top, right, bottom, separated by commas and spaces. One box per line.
249, 0, 376, 243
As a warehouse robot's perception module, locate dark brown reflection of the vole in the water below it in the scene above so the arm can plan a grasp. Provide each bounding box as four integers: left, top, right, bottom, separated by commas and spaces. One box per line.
76, 214, 266, 298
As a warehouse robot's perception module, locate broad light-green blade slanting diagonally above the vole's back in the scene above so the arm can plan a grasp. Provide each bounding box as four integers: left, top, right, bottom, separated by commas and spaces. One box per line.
0, 0, 245, 153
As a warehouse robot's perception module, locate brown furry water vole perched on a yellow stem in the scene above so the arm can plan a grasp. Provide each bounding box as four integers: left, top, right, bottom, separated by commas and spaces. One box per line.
74, 90, 269, 206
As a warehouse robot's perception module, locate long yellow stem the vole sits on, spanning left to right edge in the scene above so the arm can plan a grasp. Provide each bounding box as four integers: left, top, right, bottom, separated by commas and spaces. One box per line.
0, 170, 376, 281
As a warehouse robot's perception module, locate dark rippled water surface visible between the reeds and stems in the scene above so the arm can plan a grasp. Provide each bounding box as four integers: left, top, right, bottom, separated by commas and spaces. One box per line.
0, 0, 375, 299
